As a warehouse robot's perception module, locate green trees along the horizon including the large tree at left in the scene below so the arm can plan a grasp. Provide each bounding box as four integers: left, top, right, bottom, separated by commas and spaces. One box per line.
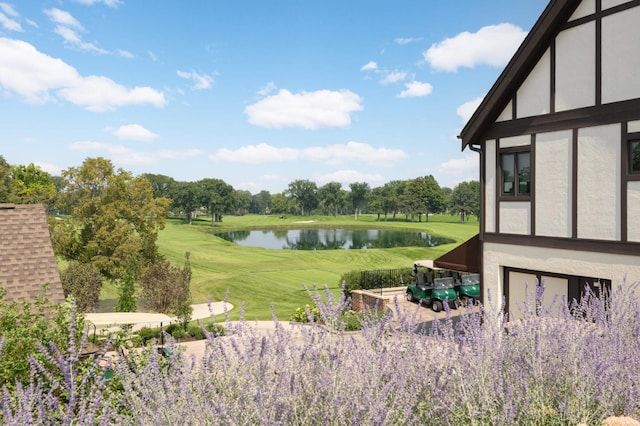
0, 156, 480, 317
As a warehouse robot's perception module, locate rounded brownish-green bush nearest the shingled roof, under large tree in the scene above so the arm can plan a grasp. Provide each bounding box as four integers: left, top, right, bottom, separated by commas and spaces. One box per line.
60, 261, 103, 312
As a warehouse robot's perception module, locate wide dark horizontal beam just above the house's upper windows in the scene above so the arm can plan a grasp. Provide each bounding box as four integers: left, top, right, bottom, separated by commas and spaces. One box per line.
484, 98, 640, 140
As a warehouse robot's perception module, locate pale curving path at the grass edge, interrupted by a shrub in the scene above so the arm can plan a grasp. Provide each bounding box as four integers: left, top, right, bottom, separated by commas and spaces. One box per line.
85, 302, 233, 331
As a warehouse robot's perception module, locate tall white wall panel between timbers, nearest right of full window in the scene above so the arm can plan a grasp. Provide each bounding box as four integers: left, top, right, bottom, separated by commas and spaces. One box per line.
534, 131, 572, 238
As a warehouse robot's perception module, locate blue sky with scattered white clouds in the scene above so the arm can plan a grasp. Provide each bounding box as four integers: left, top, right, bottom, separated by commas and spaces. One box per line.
0, 0, 547, 194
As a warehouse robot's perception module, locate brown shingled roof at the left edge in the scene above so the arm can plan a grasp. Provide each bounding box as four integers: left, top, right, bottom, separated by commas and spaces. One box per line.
0, 204, 64, 303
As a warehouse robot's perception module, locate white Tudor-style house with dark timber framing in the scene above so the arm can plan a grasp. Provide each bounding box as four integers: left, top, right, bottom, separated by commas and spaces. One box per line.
460, 0, 640, 317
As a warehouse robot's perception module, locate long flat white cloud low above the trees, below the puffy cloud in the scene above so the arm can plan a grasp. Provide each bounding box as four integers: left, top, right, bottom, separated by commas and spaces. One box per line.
209, 141, 408, 167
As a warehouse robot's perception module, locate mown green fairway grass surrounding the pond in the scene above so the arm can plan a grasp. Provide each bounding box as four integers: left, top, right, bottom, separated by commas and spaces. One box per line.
158, 215, 478, 321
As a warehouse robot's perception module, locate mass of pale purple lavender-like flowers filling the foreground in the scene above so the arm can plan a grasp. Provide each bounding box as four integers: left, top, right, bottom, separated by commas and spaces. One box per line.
5, 283, 640, 425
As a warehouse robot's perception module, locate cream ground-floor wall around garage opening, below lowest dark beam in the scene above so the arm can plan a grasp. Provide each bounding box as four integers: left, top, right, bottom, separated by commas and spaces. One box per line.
482, 243, 640, 316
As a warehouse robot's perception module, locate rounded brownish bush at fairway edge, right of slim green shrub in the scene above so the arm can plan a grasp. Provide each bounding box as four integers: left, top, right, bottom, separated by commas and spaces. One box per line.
140, 252, 191, 317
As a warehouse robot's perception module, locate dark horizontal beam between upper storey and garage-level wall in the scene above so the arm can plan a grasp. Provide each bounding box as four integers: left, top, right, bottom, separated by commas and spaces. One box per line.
483, 233, 640, 256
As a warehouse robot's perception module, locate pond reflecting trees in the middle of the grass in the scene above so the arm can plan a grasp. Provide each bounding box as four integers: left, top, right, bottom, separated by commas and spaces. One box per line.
215, 229, 455, 250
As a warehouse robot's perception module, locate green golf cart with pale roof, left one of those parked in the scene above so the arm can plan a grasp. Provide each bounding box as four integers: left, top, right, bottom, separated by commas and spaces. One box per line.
406, 260, 458, 312
